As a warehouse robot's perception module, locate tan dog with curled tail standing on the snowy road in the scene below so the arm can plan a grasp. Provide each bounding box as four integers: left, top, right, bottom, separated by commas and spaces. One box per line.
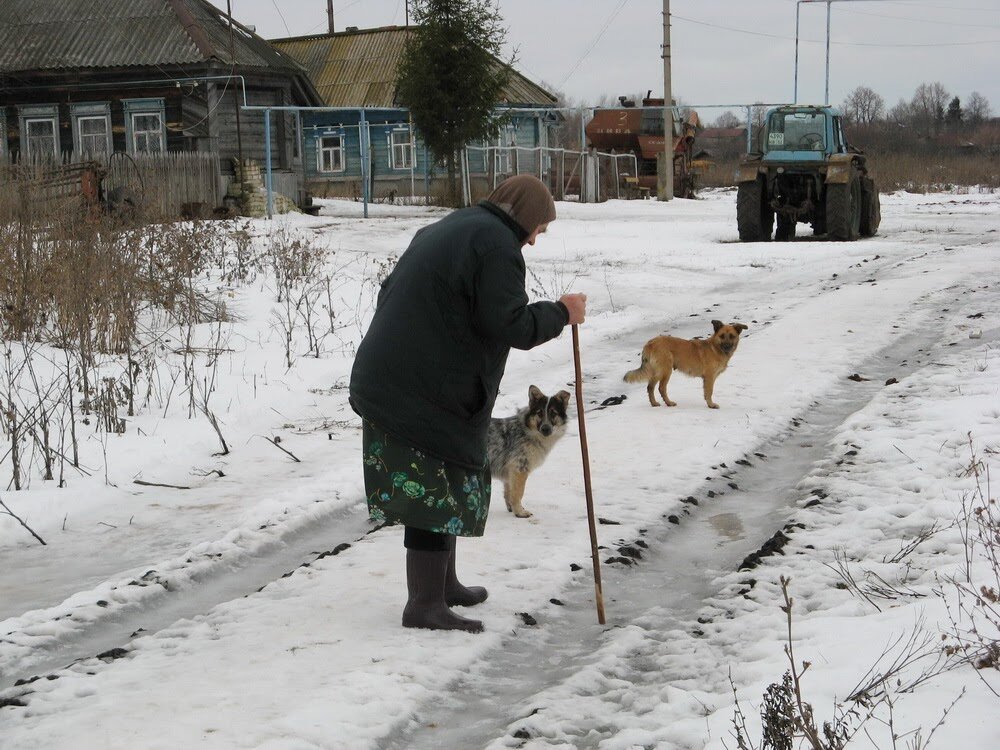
623, 320, 747, 409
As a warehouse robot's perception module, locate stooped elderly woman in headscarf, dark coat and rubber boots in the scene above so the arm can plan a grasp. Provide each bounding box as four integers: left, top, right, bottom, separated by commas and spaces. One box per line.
350, 175, 586, 632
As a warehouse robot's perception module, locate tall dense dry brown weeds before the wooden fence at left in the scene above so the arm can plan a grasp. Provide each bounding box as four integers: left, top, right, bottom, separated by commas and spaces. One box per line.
0, 185, 227, 489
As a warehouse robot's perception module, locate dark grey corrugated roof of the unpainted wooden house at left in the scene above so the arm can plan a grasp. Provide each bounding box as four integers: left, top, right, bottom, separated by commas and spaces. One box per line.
0, 0, 299, 73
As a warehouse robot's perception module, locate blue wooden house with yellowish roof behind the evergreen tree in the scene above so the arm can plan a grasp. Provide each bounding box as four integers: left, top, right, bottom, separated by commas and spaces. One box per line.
271, 26, 559, 199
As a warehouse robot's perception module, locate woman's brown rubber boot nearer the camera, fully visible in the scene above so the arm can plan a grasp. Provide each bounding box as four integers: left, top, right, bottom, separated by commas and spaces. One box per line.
403, 549, 483, 633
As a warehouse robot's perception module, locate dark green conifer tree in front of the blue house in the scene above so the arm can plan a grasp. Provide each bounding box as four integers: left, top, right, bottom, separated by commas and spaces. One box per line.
396, 0, 514, 205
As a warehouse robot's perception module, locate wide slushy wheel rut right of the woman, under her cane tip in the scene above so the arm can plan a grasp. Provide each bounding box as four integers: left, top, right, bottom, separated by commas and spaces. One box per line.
382, 284, 1000, 750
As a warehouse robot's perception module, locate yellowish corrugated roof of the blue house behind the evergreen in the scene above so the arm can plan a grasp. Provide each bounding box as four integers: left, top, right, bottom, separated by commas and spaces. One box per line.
271, 26, 556, 107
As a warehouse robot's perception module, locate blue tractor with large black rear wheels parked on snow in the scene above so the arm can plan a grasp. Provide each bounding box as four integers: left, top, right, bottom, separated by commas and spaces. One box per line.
736, 105, 881, 242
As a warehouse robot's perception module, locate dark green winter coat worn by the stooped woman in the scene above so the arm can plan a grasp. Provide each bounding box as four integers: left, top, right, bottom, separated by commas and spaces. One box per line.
350, 201, 569, 470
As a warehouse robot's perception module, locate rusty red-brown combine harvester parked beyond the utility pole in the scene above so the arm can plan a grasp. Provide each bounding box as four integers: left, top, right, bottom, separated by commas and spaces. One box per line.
584, 93, 700, 198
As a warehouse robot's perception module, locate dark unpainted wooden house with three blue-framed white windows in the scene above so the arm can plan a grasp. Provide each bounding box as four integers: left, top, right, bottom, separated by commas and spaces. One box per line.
0, 0, 321, 206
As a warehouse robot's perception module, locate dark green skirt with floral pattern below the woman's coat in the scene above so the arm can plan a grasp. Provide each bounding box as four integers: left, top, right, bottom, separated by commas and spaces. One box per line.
362, 419, 491, 536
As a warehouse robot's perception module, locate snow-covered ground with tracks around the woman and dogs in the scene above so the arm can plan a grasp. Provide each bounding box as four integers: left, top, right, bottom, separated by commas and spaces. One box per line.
0, 191, 1000, 750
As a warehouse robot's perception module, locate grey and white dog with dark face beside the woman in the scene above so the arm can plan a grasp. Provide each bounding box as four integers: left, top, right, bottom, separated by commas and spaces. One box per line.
487, 386, 569, 518
